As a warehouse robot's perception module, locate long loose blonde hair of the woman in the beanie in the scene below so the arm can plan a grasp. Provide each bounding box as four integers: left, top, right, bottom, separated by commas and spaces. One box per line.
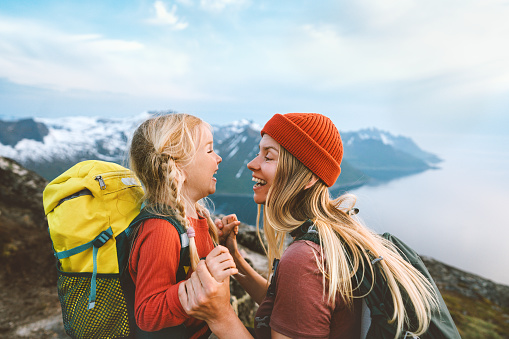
257, 147, 438, 337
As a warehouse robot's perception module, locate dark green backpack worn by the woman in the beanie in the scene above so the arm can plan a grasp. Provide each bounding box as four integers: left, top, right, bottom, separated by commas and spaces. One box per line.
288, 220, 461, 339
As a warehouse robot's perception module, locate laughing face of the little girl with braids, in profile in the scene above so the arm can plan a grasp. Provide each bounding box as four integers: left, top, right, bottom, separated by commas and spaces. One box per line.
183, 124, 222, 202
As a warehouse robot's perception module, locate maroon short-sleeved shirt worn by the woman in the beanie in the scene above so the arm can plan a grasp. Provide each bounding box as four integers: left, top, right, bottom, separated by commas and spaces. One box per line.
255, 240, 362, 339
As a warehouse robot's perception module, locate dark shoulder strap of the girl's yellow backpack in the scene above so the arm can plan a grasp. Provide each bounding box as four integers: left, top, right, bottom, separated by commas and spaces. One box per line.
126, 208, 191, 282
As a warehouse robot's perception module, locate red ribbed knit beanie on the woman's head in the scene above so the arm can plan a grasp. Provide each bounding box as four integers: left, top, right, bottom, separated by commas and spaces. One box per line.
261, 113, 343, 187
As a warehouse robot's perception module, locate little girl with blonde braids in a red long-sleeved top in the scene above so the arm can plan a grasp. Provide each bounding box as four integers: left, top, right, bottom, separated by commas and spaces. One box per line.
129, 114, 237, 338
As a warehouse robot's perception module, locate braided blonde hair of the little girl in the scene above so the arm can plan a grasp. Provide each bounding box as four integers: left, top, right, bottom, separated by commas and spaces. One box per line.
129, 113, 218, 269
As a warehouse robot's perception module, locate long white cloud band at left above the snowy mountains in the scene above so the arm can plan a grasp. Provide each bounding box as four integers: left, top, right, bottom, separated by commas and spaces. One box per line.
0, 16, 201, 99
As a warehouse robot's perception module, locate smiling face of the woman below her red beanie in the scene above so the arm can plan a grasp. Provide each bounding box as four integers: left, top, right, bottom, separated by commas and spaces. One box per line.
247, 134, 279, 204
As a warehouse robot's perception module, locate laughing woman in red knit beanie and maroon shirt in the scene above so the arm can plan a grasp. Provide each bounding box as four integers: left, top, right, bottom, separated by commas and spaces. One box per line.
179, 113, 437, 338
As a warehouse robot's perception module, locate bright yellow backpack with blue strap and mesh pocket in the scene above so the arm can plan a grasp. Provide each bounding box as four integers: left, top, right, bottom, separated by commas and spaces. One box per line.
43, 160, 143, 338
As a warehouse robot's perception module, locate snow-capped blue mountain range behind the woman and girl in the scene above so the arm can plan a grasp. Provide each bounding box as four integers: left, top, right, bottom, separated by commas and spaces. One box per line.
0, 113, 439, 194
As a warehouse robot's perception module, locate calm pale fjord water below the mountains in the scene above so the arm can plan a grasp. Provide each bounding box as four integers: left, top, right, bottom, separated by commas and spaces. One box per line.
212, 135, 509, 285
